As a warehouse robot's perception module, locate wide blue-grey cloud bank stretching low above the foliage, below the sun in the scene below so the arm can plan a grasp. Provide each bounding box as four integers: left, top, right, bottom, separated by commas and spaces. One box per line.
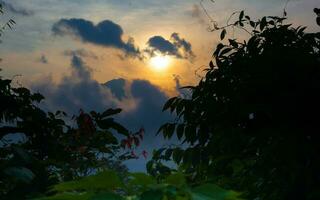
32, 55, 175, 171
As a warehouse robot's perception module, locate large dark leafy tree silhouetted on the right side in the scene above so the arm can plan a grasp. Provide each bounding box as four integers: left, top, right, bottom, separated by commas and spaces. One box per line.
154, 11, 320, 199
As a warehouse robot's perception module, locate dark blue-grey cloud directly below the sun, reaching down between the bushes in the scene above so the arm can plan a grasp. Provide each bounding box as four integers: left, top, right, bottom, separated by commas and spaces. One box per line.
108, 80, 178, 171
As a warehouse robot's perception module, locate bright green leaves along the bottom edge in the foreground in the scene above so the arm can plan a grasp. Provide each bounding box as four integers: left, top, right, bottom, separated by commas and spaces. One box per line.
37, 171, 240, 200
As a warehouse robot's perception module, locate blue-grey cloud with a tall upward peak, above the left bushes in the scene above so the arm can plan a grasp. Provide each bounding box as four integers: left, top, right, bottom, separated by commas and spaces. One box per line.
32, 56, 116, 114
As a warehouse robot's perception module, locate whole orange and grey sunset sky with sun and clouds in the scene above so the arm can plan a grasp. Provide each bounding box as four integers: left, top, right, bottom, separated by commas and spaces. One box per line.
0, 0, 319, 171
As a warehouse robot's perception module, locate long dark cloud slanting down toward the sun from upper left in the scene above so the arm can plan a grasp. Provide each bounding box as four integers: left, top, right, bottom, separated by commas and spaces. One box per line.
52, 18, 140, 58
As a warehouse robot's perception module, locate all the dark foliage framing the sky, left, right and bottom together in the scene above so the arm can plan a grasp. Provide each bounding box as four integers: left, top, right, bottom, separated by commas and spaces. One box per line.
0, 1, 320, 200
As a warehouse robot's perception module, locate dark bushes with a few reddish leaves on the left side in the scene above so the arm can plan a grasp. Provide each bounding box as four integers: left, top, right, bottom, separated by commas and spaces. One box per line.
0, 74, 143, 199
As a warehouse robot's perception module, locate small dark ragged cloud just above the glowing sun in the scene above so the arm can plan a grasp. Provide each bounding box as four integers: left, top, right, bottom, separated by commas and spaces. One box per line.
144, 33, 195, 62
